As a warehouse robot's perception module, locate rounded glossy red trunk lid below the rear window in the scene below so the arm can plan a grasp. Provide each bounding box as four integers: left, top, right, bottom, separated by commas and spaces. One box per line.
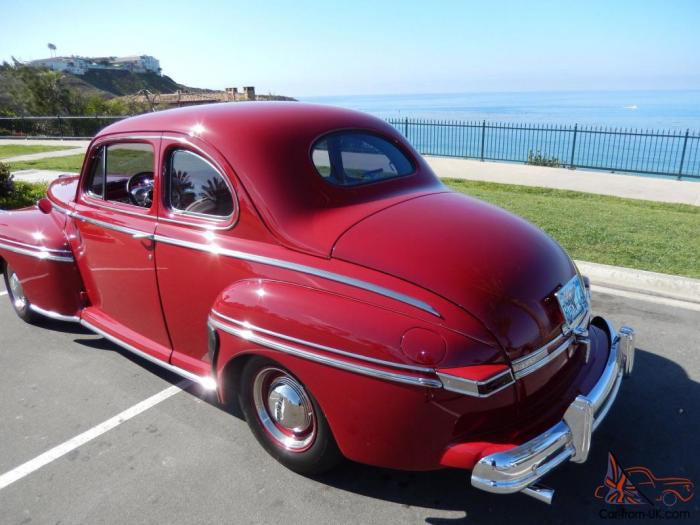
333, 192, 577, 359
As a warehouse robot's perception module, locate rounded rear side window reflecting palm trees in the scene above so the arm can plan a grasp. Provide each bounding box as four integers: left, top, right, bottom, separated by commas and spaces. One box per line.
166, 150, 234, 218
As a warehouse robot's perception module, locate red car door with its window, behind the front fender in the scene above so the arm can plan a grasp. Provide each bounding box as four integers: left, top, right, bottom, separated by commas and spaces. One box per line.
71, 136, 171, 361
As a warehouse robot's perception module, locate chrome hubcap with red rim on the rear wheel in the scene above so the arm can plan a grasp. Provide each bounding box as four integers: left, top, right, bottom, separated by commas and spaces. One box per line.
253, 367, 316, 452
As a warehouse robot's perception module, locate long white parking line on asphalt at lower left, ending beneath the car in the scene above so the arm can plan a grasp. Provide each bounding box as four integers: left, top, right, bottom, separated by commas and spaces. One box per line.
0, 380, 192, 490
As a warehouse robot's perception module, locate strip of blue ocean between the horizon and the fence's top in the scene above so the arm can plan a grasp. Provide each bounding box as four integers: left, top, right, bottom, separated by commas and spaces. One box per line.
299, 90, 700, 132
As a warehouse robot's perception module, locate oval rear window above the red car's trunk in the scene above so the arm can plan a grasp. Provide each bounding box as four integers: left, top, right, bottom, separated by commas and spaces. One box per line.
311, 132, 414, 186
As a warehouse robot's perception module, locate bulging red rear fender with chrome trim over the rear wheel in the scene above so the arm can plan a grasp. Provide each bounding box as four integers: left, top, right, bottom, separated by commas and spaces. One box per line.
209, 279, 512, 470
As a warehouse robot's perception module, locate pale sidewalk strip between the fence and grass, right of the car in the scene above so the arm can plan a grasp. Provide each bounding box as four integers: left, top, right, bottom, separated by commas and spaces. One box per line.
425, 156, 700, 206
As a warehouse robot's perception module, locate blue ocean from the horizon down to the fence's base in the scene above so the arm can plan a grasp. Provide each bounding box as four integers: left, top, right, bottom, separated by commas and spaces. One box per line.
301, 90, 700, 181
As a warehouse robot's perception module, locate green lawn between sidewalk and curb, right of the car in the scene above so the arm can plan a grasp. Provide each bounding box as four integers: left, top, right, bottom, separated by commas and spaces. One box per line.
443, 179, 700, 278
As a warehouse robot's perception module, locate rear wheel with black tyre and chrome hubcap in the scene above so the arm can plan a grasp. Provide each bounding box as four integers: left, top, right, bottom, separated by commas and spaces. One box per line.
238, 357, 342, 475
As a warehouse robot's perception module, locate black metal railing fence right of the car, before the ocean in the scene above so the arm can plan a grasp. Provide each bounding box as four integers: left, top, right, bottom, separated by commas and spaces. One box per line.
388, 118, 700, 179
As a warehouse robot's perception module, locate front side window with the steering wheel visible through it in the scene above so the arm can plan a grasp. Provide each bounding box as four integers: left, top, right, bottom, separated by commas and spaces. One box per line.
87, 142, 154, 208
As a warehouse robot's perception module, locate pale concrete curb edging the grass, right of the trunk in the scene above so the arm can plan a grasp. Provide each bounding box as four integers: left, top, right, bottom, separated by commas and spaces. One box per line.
574, 261, 700, 305
